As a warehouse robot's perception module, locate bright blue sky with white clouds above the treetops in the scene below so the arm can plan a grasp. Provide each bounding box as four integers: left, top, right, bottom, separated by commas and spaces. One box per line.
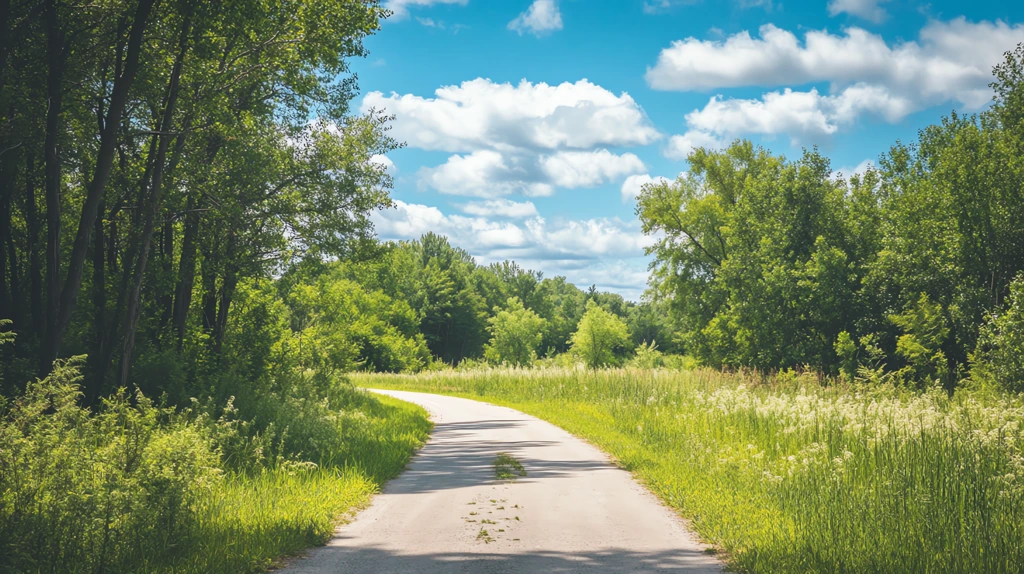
353, 0, 1024, 300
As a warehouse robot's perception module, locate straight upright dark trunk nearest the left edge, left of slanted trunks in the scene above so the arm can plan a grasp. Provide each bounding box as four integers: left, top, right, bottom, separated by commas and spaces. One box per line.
39, 0, 68, 374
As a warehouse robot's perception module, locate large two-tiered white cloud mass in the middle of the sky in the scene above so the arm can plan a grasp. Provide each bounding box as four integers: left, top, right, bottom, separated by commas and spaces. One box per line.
362, 78, 662, 197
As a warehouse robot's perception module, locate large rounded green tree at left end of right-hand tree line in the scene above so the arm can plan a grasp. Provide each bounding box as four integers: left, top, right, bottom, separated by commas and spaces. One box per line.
637, 141, 870, 369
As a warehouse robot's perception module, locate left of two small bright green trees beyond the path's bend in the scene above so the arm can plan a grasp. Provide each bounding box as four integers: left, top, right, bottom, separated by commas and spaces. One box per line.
483, 297, 547, 366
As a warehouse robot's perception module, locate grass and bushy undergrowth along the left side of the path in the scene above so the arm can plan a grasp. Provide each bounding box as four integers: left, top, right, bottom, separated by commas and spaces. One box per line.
0, 360, 430, 573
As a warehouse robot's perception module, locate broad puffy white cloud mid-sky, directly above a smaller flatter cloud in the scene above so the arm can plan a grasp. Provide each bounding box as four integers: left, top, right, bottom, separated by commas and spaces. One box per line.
361, 78, 660, 151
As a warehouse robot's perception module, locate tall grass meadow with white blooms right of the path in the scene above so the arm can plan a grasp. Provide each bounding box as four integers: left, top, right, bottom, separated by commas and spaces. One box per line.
355, 368, 1024, 573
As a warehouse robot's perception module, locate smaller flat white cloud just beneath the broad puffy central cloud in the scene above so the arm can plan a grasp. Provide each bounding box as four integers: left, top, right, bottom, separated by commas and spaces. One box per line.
420, 149, 645, 197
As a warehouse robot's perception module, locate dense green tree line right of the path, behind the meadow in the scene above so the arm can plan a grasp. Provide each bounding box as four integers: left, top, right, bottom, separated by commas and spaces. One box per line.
637, 42, 1024, 389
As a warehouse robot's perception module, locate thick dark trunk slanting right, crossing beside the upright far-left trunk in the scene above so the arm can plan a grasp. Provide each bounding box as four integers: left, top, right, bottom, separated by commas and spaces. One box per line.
43, 0, 157, 362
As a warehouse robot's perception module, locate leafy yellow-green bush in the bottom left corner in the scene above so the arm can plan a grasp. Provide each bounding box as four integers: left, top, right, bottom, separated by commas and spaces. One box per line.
0, 359, 221, 572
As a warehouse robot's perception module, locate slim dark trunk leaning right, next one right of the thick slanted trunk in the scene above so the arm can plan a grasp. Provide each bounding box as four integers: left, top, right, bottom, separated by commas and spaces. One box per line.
118, 17, 191, 387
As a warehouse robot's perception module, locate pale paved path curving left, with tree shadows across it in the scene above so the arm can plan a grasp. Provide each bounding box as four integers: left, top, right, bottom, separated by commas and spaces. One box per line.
285, 391, 722, 574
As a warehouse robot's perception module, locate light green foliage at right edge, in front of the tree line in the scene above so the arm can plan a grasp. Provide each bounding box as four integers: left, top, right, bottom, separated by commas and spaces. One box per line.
971, 275, 1024, 393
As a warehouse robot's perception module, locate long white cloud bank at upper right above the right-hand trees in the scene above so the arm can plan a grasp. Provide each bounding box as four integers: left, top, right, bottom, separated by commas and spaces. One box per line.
647, 18, 1024, 148
